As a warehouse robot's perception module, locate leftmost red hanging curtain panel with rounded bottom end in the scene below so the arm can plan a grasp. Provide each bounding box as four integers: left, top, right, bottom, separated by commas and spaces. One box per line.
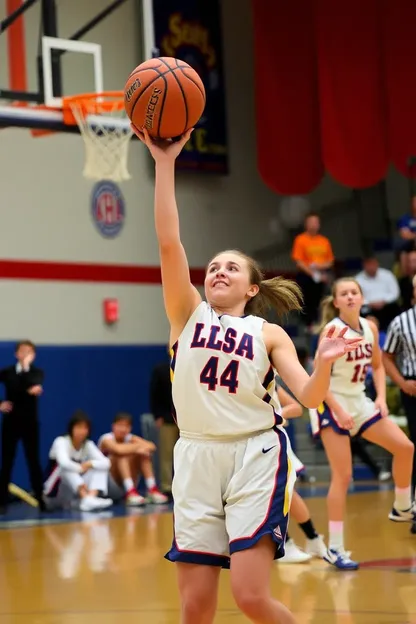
253, 0, 324, 195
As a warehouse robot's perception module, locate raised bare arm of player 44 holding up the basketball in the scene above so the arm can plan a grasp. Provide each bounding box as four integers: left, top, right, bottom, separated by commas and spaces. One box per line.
133, 128, 201, 340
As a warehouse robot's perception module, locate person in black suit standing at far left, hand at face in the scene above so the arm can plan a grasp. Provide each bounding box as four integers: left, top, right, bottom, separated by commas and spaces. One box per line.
0, 340, 44, 513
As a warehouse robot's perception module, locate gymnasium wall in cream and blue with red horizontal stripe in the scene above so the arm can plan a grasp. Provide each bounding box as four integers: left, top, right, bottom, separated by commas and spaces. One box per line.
0, 0, 357, 485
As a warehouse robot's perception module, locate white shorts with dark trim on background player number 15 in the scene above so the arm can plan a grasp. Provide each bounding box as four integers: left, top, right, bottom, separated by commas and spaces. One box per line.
309, 393, 382, 437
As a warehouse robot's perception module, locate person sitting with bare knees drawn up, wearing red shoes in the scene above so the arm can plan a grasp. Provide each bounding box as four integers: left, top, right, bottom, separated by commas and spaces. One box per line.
98, 412, 168, 507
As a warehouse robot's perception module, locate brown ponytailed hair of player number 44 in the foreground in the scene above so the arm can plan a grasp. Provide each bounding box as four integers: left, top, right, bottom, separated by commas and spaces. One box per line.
208, 249, 303, 317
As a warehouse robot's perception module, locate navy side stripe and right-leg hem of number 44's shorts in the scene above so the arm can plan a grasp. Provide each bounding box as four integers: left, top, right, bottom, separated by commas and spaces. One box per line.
230, 427, 289, 559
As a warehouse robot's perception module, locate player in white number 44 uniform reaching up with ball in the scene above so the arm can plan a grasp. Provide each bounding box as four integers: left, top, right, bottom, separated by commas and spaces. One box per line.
136, 130, 357, 624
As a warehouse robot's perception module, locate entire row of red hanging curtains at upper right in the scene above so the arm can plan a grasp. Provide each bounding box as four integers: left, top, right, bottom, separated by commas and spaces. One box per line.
252, 0, 416, 194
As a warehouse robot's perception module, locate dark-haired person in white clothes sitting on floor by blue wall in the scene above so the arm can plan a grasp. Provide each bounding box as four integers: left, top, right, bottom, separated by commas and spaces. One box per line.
43, 410, 113, 511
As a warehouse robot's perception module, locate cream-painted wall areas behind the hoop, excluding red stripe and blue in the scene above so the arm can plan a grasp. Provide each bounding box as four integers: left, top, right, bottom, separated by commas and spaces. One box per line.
0, 0, 356, 342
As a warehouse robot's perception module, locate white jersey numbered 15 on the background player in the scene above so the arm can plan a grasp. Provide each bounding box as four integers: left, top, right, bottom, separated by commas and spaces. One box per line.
324, 317, 374, 396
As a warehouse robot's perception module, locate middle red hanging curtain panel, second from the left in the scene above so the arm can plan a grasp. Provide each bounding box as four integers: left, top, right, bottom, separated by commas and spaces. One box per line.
315, 0, 388, 188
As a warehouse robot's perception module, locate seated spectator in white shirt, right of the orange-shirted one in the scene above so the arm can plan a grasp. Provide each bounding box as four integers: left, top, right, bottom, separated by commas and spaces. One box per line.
355, 256, 400, 331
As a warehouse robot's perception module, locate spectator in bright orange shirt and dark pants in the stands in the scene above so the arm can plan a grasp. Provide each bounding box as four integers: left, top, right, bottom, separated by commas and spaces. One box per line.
292, 212, 334, 330
